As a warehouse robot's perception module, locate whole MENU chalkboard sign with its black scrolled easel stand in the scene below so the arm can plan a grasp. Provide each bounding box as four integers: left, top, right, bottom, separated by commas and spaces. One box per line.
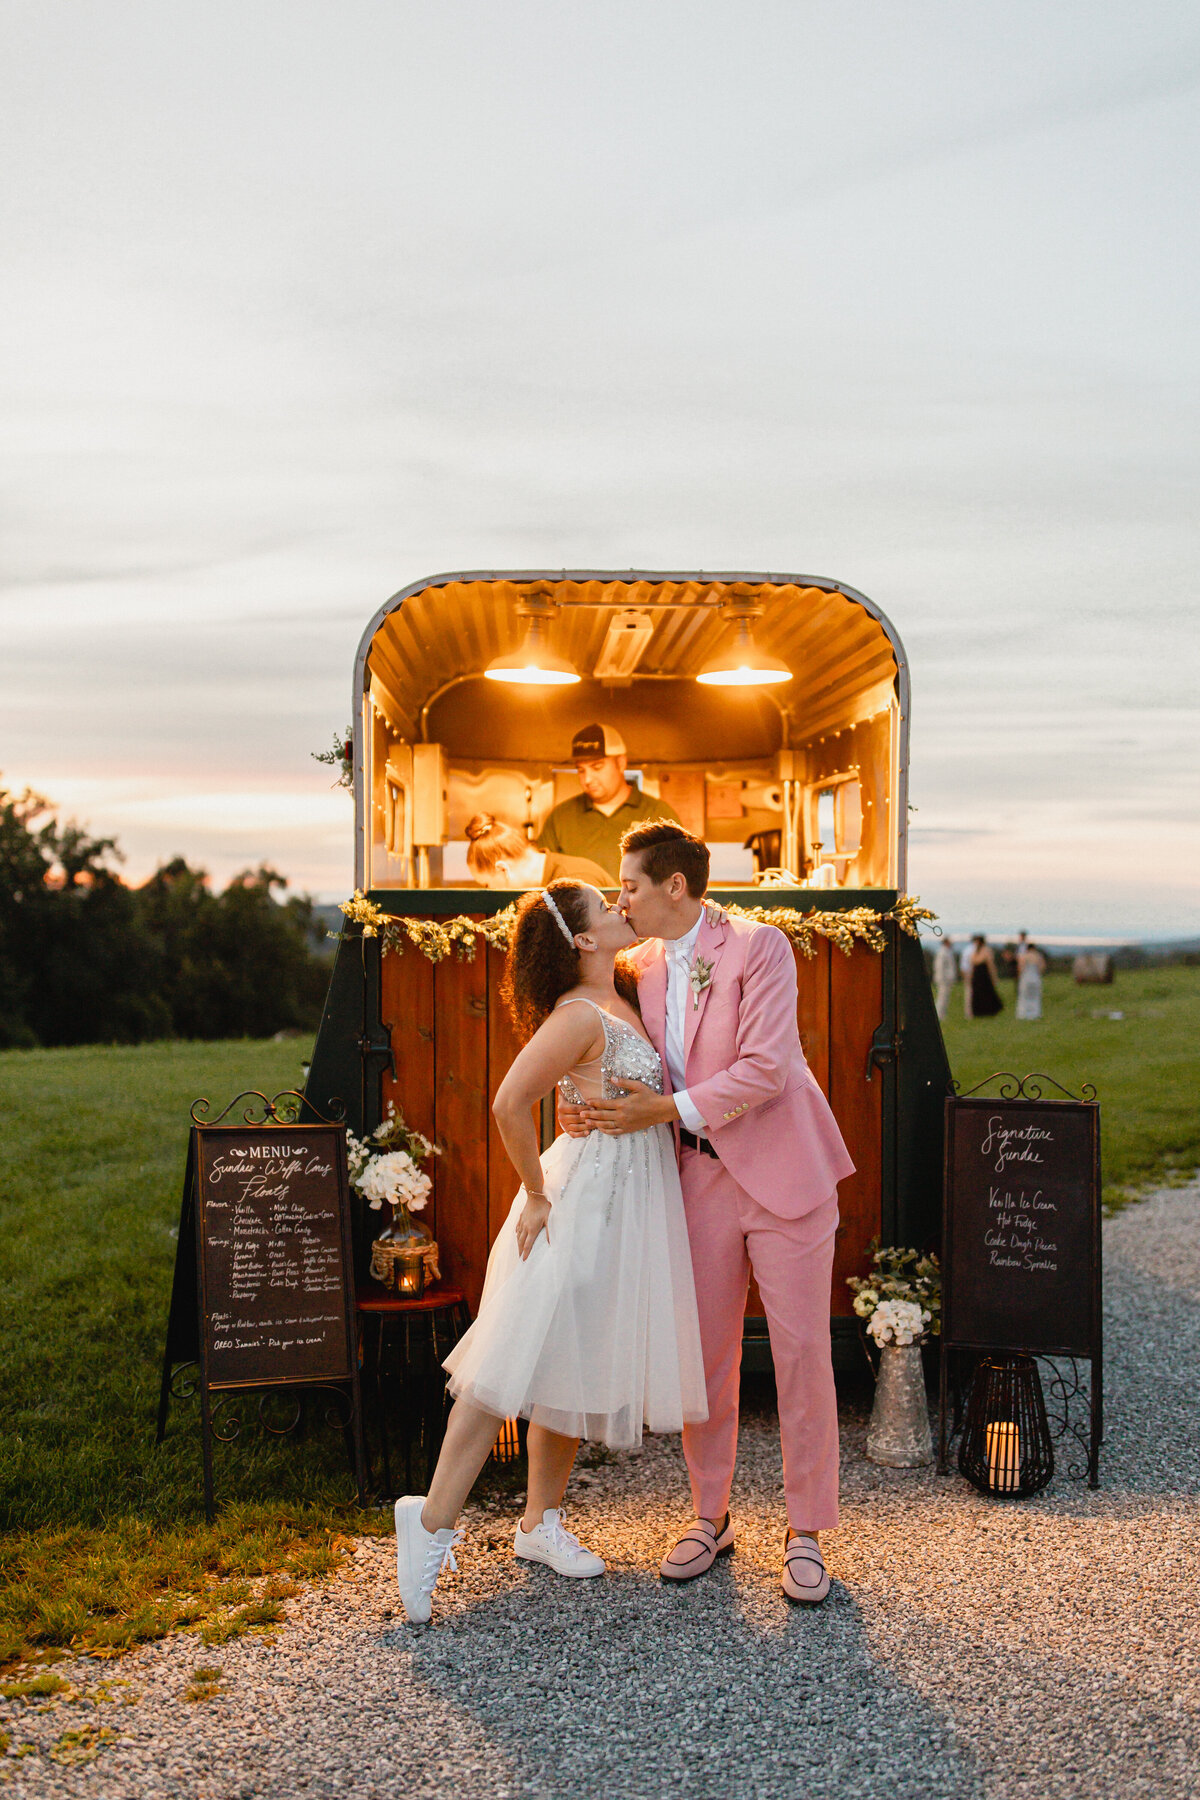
158, 1094, 365, 1517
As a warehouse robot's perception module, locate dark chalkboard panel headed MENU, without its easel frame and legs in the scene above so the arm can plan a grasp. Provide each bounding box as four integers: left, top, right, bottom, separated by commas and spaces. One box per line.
196, 1125, 354, 1388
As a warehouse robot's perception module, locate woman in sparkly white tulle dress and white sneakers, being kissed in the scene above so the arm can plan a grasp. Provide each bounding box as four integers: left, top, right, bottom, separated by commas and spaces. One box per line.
396, 880, 707, 1624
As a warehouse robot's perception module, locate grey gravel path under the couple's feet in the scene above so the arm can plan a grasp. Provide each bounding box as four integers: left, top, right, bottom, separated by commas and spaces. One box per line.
0, 1181, 1200, 1800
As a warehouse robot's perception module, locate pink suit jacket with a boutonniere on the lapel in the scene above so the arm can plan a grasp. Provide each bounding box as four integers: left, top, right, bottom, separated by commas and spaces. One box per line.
631, 907, 855, 1219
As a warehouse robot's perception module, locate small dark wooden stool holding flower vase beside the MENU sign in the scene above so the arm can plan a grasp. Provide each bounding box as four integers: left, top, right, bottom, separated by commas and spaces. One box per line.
356, 1280, 470, 1498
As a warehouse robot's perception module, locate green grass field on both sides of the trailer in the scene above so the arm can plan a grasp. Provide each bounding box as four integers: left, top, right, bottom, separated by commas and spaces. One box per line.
0, 968, 1200, 1663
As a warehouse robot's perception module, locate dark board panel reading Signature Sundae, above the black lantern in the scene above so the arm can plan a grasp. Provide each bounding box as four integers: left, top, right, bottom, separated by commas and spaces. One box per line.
943, 1100, 1099, 1355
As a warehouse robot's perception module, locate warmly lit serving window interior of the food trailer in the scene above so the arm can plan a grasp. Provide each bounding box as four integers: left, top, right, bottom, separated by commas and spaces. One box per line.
358, 576, 903, 889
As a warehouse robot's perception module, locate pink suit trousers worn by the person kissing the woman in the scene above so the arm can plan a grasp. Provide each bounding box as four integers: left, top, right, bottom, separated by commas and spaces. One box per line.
680, 1150, 838, 1532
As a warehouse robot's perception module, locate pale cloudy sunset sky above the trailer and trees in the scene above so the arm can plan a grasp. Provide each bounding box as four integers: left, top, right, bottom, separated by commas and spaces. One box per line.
0, 0, 1200, 936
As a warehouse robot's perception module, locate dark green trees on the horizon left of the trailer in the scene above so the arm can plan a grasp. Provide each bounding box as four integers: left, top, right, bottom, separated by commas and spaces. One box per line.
0, 787, 329, 1048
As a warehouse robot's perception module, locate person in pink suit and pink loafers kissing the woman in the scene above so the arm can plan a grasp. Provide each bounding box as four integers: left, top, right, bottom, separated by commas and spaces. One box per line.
565, 821, 855, 1604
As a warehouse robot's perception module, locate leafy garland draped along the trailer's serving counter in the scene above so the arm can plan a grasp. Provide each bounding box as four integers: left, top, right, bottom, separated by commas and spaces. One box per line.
333, 887, 937, 963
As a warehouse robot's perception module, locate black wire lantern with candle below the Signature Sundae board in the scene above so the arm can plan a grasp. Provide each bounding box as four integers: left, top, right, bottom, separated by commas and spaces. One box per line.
959, 1355, 1054, 1499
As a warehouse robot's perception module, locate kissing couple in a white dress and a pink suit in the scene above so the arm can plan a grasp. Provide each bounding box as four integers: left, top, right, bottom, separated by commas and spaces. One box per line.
396, 821, 853, 1624
